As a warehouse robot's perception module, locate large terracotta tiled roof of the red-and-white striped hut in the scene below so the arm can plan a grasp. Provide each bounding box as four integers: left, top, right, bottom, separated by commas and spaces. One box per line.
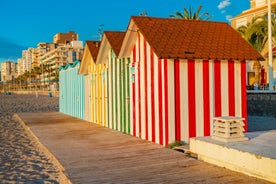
131, 16, 262, 60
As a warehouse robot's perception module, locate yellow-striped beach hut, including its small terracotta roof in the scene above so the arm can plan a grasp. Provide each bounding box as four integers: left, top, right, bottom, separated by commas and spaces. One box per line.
78, 41, 100, 123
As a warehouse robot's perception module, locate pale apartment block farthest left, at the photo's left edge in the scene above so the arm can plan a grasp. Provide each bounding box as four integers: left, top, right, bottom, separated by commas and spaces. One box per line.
1, 61, 17, 82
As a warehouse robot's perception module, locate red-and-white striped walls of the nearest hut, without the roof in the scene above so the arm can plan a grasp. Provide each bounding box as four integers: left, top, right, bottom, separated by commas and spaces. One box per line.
130, 32, 247, 145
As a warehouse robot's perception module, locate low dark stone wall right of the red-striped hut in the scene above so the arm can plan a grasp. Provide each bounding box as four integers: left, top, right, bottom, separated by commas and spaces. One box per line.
247, 91, 276, 117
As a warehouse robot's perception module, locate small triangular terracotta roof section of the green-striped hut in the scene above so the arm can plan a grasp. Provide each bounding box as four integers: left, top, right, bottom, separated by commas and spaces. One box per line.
104, 31, 125, 56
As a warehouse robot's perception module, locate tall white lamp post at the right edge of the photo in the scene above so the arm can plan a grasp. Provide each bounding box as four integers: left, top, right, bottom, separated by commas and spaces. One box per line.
267, 0, 274, 91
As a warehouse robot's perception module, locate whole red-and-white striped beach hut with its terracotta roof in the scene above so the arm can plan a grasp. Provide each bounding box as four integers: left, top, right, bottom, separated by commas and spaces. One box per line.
119, 16, 262, 145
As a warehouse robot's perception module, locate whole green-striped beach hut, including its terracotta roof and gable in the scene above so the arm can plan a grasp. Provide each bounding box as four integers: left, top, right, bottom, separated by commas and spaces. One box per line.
96, 31, 129, 133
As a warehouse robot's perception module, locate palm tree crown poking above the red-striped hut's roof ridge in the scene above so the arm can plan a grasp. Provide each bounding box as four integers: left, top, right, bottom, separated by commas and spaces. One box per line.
170, 5, 212, 20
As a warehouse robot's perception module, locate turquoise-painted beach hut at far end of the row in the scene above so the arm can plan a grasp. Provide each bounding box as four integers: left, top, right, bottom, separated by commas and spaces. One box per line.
59, 60, 84, 119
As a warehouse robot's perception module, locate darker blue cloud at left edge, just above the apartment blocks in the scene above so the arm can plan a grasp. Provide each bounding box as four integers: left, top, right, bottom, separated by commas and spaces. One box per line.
0, 37, 27, 61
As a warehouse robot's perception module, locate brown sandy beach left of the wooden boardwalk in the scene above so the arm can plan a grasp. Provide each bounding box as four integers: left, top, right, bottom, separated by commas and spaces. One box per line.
0, 94, 68, 183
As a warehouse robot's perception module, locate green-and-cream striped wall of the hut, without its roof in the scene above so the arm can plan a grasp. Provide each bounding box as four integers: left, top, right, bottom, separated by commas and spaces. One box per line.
105, 49, 131, 134
